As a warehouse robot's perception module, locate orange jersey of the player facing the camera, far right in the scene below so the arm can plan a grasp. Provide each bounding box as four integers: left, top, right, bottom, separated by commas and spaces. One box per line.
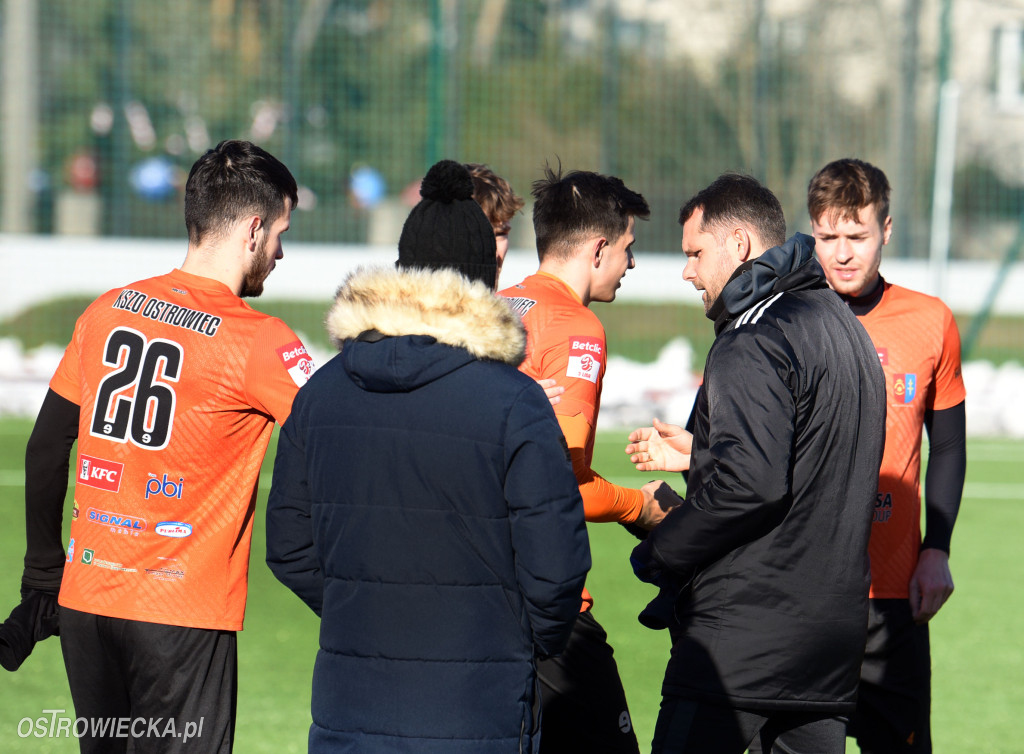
858, 283, 967, 598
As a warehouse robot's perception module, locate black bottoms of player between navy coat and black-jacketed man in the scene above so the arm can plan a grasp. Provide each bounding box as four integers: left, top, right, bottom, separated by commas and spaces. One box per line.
537, 611, 640, 754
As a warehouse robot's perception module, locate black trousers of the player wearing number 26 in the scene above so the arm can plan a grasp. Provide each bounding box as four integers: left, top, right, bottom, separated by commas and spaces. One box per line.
60, 608, 238, 754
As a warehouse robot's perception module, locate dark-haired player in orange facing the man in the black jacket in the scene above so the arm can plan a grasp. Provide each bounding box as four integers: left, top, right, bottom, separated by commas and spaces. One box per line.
502, 168, 664, 752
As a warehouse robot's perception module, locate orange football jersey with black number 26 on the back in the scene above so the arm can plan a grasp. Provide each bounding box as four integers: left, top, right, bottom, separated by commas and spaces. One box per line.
50, 269, 313, 630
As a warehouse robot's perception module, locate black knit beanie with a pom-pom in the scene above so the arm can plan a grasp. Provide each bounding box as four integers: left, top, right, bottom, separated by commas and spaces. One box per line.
397, 160, 498, 288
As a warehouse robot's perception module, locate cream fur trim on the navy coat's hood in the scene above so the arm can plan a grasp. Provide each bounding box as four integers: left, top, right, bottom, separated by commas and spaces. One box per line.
326, 267, 526, 374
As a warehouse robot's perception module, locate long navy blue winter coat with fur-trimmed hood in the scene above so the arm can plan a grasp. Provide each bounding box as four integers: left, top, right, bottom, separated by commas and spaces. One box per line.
266, 268, 590, 754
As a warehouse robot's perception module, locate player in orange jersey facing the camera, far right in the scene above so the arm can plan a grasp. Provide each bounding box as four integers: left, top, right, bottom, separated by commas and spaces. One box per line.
807, 159, 967, 754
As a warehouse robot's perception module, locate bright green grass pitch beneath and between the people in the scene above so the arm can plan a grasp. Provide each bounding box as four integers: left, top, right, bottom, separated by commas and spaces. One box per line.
0, 419, 1024, 754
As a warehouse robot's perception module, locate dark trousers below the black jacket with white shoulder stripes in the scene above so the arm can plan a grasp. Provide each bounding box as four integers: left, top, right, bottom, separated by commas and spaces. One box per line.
651, 697, 846, 754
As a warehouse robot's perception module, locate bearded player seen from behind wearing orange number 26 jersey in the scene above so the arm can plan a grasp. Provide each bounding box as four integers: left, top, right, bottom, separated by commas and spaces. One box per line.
9, 141, 313, 754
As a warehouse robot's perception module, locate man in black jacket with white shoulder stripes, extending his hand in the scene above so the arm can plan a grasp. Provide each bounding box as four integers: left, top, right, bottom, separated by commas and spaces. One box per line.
627, 174, 885, 754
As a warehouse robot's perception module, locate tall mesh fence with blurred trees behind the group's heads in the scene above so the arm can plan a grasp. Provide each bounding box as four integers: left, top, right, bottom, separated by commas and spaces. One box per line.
0, 0, 1024, 377
